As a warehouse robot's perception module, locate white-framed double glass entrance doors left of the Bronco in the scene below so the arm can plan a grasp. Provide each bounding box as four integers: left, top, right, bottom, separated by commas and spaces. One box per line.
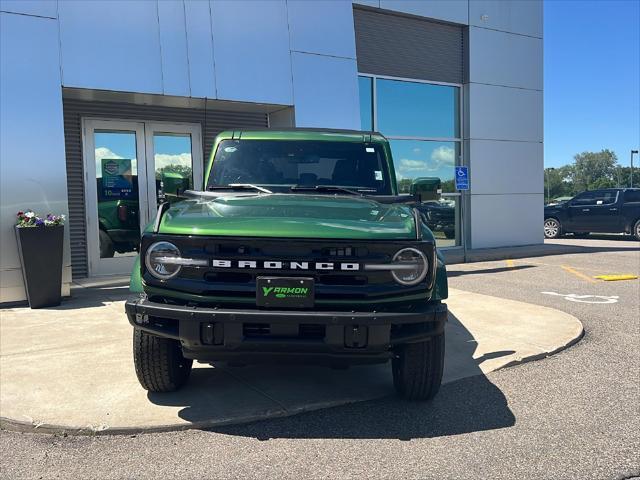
83, 119, 203, 276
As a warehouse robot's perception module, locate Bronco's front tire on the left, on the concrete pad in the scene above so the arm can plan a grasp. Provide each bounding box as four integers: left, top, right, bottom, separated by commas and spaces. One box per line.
133, 328, 193, 392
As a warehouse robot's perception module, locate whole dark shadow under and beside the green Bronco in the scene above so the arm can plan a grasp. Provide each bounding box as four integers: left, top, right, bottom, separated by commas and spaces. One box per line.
148, 313, 515, 440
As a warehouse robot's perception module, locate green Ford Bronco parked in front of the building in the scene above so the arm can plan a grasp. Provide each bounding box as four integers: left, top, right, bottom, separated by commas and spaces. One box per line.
126, 129, 447, 399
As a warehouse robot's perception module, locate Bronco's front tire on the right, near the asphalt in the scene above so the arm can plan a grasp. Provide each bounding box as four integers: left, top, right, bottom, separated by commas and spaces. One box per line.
392, 333, 444, 400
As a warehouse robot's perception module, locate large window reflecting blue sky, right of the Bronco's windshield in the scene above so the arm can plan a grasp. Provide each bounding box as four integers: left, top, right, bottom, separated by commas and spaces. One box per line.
359, 75, 462, 247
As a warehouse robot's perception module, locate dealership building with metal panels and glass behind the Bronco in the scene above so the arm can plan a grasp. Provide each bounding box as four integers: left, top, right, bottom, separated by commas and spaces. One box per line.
0, 0, 543, 303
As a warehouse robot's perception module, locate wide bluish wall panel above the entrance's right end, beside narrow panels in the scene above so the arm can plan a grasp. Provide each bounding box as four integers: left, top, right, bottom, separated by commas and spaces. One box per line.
210, 0, 293, 105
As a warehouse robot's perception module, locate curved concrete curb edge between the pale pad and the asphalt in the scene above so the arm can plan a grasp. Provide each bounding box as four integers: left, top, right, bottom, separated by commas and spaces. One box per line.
0, 317, 585, 436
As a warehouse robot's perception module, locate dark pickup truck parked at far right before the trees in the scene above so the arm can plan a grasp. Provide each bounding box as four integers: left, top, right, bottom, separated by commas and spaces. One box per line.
544, 188, 640, 240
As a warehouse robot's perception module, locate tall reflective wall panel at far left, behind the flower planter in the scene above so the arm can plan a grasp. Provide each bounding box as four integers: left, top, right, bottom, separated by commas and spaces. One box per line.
0, 13, 70, 302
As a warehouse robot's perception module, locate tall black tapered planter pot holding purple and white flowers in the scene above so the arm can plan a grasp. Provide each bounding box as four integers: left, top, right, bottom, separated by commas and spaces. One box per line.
16, 225, 64, 308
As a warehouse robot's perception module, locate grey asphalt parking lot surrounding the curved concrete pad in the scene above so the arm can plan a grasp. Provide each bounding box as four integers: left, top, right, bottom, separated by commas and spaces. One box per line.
0, 237, 640, 479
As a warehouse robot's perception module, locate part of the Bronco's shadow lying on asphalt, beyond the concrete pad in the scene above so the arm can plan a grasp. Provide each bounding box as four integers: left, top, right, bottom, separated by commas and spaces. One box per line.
207, 375, 516, 440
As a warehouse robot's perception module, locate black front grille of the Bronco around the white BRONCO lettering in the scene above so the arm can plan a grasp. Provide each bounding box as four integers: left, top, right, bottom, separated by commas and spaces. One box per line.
141, 235, 435, 309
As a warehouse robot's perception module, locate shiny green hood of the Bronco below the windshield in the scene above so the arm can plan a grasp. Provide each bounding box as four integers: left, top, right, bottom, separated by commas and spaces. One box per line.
158, 193, 416, 240
